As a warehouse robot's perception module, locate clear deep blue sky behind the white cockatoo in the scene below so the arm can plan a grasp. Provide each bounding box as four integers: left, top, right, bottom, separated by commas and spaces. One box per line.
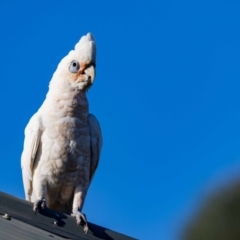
0, 0, 240, 240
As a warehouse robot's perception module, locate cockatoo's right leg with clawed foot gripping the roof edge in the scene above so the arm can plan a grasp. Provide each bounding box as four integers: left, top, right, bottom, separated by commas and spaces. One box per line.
71, 187, 88, 234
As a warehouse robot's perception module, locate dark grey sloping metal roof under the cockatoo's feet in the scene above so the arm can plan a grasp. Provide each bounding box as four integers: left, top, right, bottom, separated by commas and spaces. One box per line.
0, 192, 137, 240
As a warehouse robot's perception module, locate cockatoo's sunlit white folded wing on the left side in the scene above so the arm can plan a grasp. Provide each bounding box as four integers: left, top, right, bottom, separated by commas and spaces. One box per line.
21, 113, 42, 201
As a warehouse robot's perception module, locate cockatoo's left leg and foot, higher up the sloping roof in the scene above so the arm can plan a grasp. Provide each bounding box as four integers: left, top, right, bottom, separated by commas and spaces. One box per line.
33, 181, 47, 214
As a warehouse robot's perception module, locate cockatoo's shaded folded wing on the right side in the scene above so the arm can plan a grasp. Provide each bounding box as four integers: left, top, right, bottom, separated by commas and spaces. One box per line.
88, 114, 103, 183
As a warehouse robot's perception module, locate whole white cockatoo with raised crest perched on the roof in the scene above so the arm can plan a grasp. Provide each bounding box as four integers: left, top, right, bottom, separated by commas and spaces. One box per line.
21, 33, 102, 233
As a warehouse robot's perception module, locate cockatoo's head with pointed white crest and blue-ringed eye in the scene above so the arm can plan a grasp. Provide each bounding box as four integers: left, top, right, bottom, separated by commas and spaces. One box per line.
54, 33, 96, 90
